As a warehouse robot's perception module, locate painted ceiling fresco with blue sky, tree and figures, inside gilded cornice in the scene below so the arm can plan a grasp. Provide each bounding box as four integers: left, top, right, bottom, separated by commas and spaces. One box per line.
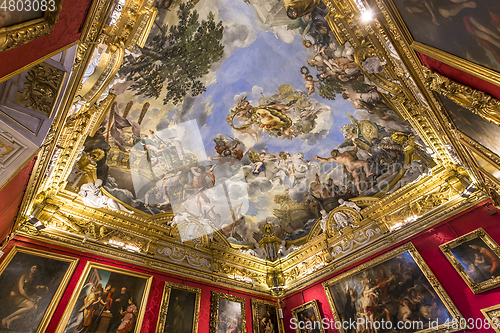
78, 0, 433, 245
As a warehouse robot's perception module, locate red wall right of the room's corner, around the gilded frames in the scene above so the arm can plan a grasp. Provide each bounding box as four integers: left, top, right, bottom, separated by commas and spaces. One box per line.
282, 203, 500, 333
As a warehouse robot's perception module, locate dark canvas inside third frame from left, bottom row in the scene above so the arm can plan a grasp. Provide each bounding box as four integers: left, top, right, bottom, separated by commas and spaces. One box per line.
163, 288, 196, 333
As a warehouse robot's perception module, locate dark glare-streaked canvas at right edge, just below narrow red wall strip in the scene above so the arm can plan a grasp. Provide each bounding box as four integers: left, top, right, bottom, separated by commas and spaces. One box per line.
439, 96, 500, 156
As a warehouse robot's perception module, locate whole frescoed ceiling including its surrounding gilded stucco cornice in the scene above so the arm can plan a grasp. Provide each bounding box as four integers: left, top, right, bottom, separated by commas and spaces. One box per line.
10, 0, 496, 290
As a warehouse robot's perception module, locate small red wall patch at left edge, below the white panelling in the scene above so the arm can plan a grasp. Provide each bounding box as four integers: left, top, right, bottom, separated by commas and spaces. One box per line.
0, 158, 36, 244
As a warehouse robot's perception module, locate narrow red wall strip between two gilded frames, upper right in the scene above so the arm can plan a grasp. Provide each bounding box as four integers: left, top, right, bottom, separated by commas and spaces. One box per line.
417, 52, 500, 99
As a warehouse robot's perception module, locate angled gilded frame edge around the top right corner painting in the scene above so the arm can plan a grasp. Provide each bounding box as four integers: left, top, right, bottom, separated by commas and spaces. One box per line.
377, 0, 500, 86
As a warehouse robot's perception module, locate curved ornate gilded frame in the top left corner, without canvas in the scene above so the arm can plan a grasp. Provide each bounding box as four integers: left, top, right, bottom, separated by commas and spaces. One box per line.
0, 0, 62, 52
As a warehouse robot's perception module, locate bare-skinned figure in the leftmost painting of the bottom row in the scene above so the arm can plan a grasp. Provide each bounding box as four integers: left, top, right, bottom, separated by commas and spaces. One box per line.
2, 265, 49, 329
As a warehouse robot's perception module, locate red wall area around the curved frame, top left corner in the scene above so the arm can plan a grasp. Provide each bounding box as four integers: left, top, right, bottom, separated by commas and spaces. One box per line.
0, 0, 92, 78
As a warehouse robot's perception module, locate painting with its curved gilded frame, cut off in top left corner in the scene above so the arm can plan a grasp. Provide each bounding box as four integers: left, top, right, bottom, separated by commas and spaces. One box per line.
0, 0, 62, 51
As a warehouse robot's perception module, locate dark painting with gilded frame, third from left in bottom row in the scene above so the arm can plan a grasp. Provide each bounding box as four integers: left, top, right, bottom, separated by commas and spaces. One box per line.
156, 281, 201, 333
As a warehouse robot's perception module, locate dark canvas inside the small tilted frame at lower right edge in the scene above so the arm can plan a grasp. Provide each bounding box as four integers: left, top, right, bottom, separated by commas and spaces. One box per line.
451, 238, 500, 283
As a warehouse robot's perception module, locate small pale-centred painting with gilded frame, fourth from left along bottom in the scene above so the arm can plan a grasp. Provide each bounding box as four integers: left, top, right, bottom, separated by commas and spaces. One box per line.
210, 291, 247, 333
